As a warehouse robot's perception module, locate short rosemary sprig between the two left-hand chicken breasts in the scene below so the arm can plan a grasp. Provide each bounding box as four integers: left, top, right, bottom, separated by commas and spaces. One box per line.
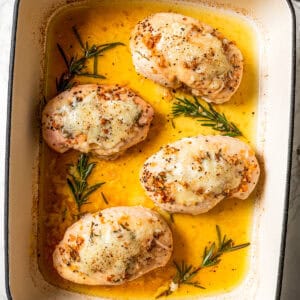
67, 154, 105, 211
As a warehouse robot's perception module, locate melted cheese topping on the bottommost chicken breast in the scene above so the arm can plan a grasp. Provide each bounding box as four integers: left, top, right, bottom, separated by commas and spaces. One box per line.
80, 217, 156, 281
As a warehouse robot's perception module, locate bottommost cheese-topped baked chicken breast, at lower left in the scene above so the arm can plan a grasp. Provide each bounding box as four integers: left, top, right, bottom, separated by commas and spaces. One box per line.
53, 207, 173, 285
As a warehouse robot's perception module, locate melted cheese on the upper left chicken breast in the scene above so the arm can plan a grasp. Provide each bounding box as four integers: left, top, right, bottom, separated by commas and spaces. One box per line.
58, 92, 141, 149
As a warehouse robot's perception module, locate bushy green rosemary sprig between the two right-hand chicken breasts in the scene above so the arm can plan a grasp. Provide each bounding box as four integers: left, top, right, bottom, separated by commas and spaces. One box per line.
172, 97, 243, 137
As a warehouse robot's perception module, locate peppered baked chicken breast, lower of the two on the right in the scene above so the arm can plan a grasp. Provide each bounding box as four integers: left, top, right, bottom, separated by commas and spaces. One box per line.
140, 136, 260, 215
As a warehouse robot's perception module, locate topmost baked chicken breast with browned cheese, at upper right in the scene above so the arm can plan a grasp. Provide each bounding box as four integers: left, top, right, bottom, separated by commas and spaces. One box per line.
130, 13, 243, 104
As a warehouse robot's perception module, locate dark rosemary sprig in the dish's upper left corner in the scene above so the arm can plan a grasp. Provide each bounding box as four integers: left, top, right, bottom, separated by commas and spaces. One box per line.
56, 26, 124, 93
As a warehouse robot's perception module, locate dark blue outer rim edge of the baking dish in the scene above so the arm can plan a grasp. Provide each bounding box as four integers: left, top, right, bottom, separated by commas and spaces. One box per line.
4, 0, 296, 300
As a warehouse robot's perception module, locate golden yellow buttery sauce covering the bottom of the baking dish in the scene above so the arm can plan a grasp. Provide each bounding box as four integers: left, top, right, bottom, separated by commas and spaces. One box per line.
39, 0, 258, 299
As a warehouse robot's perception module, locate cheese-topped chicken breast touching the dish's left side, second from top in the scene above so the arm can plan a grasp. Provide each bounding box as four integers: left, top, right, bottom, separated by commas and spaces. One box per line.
42, 84, 153, 159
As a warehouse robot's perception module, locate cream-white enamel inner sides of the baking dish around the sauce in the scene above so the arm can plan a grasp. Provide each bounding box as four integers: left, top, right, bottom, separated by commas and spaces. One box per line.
5, 0, 295, 300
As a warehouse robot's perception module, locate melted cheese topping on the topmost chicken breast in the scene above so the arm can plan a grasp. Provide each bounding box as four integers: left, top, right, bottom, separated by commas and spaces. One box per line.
154, 22, 232, 80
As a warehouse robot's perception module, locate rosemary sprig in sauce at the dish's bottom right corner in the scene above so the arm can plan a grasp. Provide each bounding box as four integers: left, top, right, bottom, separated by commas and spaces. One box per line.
156, 225, 250, 299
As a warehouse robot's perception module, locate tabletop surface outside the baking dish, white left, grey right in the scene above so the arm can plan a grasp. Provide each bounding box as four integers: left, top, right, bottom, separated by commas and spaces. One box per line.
0, 0, 300, 300
